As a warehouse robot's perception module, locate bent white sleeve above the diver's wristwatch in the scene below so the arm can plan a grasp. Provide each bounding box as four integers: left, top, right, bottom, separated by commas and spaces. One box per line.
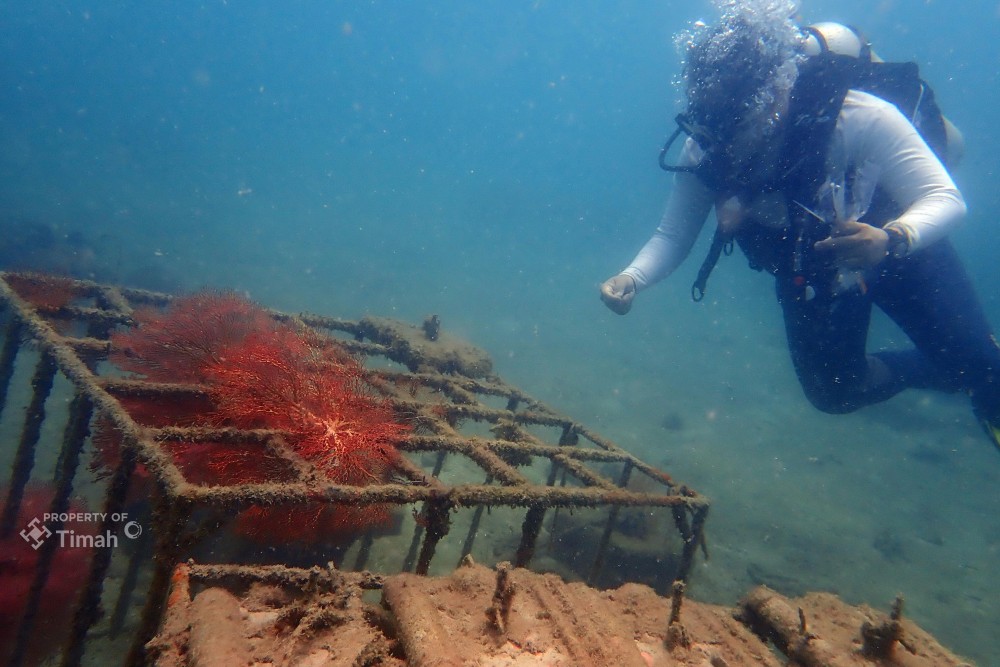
844, 91, 966, 252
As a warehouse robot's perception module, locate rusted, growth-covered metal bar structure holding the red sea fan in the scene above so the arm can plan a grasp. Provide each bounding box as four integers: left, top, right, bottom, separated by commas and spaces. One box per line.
0, 273, 709, 665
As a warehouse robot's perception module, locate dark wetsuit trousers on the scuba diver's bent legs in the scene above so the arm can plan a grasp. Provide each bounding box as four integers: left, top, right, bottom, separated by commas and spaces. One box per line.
777, 239, 1000, 421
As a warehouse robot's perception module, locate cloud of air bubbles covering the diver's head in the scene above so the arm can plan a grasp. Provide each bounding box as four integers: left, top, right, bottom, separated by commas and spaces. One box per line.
676, 0, 804, 134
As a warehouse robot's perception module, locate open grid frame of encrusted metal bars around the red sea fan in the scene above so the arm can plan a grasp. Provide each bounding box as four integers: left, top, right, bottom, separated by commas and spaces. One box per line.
0, 273, 709, 664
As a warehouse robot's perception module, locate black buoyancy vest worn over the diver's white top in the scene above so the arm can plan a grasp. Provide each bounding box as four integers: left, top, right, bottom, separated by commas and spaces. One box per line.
692, 53, 946, 300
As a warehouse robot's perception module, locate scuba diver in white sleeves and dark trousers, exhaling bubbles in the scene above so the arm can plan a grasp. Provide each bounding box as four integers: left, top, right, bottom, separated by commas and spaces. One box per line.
601, 2, 1000, 447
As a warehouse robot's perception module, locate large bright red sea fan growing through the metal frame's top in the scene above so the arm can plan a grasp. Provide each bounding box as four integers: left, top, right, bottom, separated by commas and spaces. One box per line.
112, 293, 409, 541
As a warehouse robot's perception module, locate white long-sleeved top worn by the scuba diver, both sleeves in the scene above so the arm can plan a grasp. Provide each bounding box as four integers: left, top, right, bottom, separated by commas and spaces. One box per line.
622, 90, 966, 289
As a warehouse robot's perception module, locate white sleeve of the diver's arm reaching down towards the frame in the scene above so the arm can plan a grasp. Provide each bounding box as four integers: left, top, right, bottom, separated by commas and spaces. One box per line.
621, 142, 715, 291
